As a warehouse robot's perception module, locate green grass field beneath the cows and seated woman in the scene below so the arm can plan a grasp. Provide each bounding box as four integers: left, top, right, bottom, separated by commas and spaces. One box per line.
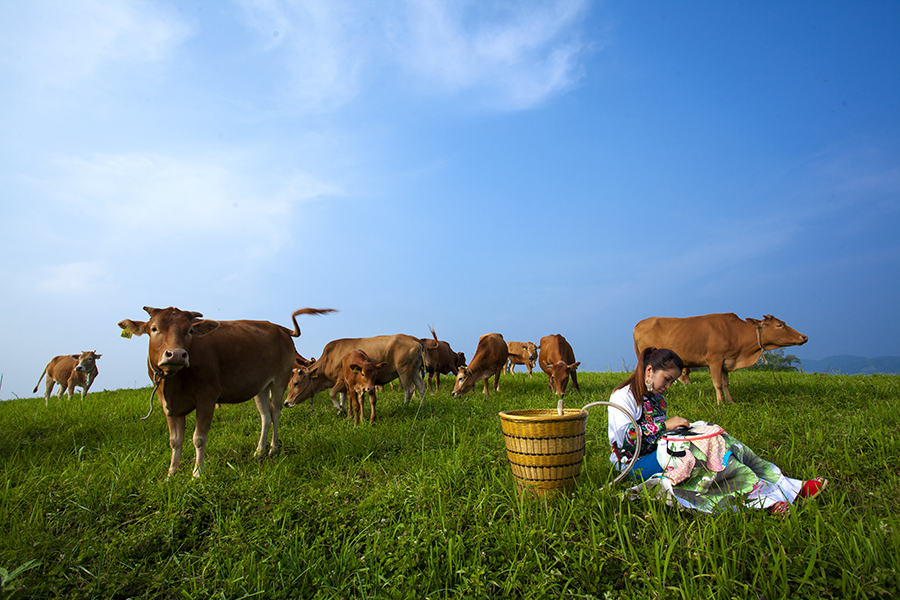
0, 367, 900, 600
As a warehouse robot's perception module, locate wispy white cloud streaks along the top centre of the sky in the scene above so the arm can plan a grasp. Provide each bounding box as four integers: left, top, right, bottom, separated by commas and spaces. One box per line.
239, 0, 588, 110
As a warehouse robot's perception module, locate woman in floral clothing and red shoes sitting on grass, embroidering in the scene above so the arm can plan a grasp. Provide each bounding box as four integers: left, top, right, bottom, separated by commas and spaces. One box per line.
607, 348, 828, 514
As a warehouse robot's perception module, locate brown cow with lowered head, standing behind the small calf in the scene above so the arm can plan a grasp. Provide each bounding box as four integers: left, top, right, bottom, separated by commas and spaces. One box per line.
284, 334, 425, 411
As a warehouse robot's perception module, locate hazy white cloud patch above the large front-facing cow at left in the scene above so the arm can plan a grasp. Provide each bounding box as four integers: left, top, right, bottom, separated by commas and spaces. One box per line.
55, 154, 341, 250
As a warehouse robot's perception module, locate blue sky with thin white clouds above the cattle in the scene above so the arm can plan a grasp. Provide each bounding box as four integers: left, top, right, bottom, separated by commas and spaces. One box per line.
0, 0, 900, 399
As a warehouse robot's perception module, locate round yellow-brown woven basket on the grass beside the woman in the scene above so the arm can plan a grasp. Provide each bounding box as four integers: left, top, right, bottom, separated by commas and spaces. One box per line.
500, 408, 587, 495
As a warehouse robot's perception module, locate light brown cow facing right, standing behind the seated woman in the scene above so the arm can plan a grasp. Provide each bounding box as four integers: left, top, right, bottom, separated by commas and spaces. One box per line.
634, 313, 809, 404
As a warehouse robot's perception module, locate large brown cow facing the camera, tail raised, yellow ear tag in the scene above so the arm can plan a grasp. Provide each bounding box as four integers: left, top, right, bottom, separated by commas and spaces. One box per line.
119, 306, 333, 477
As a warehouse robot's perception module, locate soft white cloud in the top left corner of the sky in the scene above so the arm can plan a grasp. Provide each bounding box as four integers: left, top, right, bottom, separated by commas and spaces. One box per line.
0, 0, 190, 88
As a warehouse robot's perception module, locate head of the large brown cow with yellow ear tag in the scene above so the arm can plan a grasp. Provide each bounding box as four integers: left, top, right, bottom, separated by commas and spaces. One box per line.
119, 306, 219, 375
